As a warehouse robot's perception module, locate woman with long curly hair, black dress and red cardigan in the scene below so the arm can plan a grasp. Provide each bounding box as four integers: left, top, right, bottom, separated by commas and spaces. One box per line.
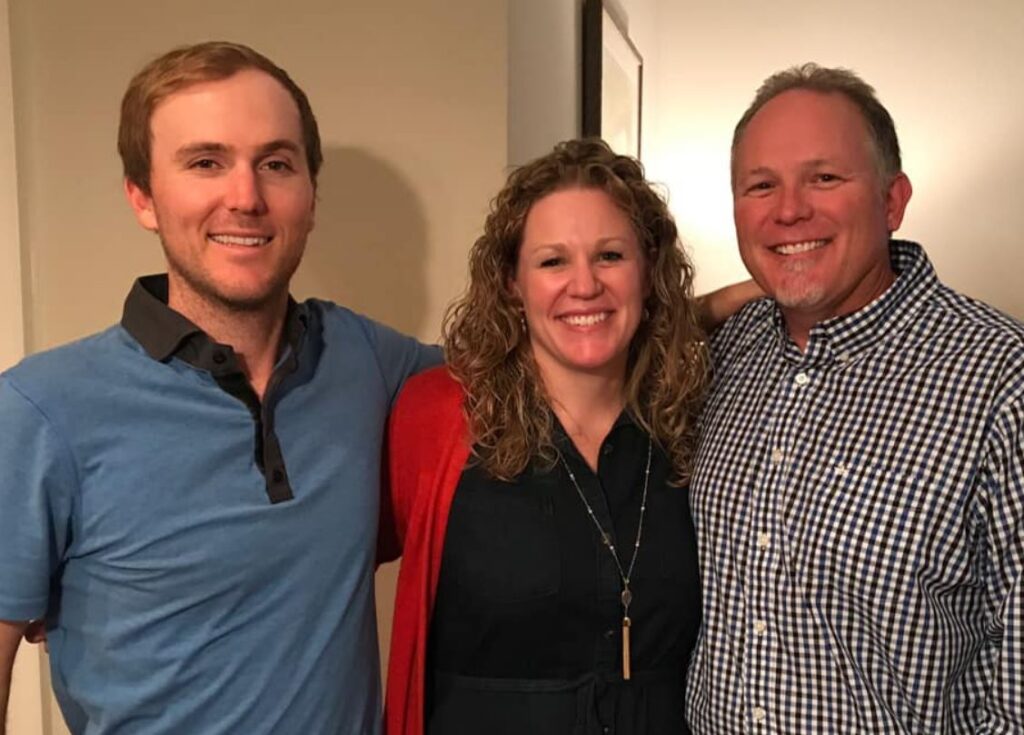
386, 140, 753, 735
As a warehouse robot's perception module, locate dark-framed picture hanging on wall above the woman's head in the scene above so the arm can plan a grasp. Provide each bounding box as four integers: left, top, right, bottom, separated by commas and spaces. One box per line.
582, 0, 643, 158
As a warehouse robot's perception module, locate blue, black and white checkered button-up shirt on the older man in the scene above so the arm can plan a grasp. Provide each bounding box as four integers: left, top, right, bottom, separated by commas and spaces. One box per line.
686, 242, 1024, 735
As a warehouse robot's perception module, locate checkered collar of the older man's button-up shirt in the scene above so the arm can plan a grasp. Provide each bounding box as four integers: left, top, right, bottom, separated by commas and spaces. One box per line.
772, 240, 939, 363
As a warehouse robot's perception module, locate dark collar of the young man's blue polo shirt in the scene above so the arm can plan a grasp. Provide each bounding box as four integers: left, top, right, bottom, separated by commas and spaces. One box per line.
121, 273, 308, 368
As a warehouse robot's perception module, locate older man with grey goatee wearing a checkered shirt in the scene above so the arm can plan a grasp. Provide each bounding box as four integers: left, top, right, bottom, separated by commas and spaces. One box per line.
687, 64, 1024, 735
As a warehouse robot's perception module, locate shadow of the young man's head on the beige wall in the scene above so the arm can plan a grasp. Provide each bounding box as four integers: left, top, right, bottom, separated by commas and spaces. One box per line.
293, 147, 427, 335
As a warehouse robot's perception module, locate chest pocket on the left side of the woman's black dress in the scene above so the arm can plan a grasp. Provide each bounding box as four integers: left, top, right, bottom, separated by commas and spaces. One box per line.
443, 486, 561, 609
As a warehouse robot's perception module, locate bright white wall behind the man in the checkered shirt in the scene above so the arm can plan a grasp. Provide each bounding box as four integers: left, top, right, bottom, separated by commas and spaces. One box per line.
641, 0, 1024, 318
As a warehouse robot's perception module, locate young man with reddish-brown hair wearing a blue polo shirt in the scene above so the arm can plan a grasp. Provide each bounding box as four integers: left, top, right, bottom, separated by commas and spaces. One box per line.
0, 43, 439, 735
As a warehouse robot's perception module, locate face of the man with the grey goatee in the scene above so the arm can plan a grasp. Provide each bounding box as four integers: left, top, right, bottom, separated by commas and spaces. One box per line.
733, 90, 910, 344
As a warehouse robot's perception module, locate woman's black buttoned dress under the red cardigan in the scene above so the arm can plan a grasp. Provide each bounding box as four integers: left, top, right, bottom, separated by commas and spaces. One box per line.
425, 416, 700, 735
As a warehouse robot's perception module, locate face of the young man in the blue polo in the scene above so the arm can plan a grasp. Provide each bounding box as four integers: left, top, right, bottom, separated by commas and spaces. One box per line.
125, 65, 314, 314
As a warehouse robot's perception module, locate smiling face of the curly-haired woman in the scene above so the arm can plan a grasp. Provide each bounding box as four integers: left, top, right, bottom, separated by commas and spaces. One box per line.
511, 188, 648, 384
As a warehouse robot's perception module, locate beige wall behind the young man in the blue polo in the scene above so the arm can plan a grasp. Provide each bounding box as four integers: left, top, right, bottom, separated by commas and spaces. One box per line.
0, 0, 508, 735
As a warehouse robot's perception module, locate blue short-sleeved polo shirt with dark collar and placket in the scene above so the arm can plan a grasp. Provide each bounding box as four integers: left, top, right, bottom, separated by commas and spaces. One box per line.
0, 276, 439, 735
